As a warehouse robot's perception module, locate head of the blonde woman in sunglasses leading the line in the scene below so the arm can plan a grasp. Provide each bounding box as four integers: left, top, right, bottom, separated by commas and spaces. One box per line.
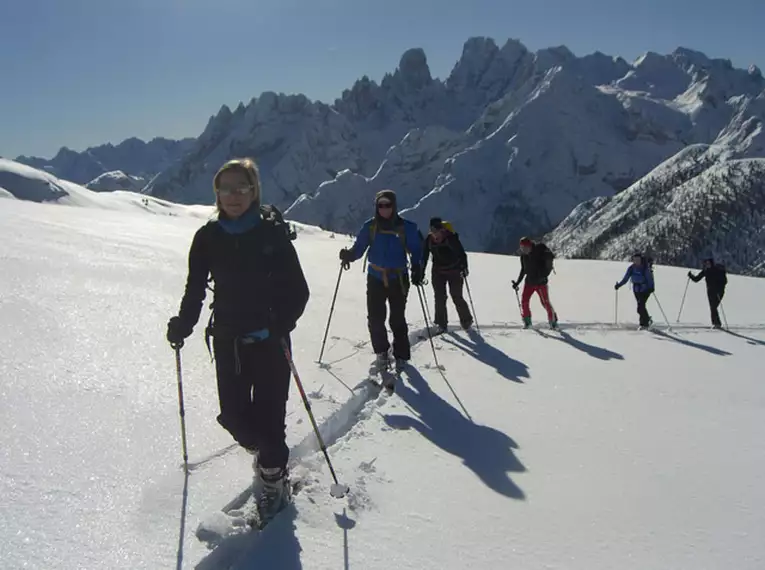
213, 158, 260, 219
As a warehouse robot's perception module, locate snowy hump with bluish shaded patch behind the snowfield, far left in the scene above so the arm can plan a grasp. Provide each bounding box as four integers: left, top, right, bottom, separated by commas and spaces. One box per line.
0, 158, 209, 217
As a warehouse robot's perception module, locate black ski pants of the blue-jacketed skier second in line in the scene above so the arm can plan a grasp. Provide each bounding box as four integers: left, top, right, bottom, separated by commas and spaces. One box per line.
367, 272, 411, 360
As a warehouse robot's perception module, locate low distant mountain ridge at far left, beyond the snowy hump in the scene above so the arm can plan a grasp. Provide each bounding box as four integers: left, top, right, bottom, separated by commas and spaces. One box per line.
15, 138, 194, 184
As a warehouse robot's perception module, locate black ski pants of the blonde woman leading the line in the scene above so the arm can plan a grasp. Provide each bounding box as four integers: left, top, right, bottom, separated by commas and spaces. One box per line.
213, 337, 291, 468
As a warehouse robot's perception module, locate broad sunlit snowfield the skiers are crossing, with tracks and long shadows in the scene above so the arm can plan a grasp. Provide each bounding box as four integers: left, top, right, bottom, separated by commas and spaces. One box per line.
0, 196, 765, 570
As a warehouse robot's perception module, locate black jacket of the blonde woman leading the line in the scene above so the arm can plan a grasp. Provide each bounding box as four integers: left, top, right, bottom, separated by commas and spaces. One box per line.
179, 210, 309, 336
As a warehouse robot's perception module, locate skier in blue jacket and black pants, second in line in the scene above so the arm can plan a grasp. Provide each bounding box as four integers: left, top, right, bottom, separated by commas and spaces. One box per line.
340, 190, 423, 371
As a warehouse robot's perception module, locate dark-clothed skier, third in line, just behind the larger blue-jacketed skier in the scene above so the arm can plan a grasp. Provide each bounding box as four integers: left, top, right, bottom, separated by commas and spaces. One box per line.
422, 218, 473, 333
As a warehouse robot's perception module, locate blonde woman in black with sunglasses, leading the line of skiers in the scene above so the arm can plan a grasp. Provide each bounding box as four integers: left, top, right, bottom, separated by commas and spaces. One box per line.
167, 159, 309, 522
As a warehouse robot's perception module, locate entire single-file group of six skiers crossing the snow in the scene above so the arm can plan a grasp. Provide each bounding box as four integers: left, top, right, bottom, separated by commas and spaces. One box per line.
167, 154, 727, 522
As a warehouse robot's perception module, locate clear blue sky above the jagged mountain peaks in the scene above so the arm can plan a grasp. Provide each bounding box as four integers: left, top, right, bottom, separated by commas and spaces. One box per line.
0, 0, 765, 157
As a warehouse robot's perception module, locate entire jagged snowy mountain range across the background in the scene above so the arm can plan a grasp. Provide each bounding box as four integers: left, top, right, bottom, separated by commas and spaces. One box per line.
7, 38, 765, 273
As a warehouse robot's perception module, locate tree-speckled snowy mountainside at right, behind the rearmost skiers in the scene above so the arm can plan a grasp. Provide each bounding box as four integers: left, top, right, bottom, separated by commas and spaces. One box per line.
546, 149, 765, 276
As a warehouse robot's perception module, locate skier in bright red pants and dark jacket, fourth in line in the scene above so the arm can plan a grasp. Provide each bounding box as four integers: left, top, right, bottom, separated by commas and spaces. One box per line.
513, 237, 558, 329
